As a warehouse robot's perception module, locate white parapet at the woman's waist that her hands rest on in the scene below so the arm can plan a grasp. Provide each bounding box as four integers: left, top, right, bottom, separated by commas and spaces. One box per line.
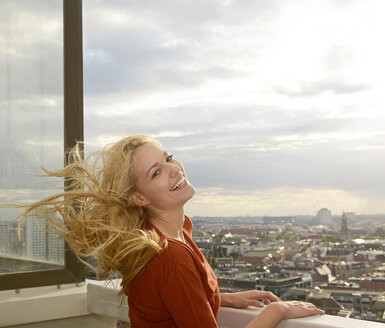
87, 280, 385, 328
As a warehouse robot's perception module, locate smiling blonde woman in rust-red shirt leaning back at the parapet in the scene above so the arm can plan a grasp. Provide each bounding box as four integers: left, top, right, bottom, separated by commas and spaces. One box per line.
15, 135, 324, 328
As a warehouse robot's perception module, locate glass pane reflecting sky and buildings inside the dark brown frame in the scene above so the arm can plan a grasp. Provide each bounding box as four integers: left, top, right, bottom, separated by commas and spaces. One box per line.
0, 0, 64, 274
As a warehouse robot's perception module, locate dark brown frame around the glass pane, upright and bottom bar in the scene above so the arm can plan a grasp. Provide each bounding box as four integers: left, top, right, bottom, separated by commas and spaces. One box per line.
0, 0, 84, 290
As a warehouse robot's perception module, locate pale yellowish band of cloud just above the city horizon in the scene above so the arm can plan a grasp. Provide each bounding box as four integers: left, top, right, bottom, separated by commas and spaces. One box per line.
186, 188, 382, 216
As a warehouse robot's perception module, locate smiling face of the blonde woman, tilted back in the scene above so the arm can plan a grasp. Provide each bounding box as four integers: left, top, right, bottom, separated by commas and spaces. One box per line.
131, 143, 195, 210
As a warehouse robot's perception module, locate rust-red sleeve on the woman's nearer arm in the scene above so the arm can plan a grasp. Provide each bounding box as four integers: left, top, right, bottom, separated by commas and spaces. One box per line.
162, 264, 218, 328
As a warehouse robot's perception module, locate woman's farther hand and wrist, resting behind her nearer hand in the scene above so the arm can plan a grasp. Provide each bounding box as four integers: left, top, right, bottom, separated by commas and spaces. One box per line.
221, 290, 280, 308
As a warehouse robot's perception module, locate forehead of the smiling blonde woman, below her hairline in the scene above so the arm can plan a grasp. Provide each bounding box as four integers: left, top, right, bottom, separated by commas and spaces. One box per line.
131, 143, 165, 175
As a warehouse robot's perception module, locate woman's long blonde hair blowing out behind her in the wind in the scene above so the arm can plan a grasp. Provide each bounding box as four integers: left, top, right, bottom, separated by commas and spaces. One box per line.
19, 135, 167, 293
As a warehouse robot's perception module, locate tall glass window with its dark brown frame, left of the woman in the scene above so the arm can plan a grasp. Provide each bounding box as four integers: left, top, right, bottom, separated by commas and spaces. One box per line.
0, 0, 83, 289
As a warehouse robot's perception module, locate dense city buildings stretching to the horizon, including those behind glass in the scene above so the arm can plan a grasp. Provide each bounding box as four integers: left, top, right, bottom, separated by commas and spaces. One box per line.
0, 208, 385, 327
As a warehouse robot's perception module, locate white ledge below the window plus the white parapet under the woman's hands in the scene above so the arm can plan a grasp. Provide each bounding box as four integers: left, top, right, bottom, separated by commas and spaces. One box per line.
0, 280, 385, 328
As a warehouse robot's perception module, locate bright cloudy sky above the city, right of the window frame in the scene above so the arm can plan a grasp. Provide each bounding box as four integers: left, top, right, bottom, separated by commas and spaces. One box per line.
83, 0, 385, 215
